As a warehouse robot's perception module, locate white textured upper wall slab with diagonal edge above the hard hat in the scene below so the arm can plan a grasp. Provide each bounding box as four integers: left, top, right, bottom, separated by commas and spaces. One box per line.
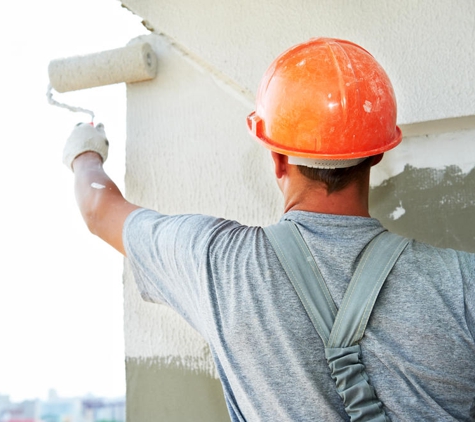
122, 0, 475, 124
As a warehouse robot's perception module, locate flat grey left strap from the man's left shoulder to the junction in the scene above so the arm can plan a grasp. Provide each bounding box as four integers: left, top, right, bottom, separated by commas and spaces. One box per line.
264, 220, 338, 345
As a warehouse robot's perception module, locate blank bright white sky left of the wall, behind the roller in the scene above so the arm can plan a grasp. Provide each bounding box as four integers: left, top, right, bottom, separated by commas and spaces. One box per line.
0, 0, 148, 401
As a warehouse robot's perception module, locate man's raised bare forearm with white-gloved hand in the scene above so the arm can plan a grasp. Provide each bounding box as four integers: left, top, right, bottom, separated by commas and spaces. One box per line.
63, 124, 139, 255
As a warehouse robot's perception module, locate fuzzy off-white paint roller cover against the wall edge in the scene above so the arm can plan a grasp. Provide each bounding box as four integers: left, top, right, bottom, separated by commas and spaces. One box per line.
48, 43, 157, 92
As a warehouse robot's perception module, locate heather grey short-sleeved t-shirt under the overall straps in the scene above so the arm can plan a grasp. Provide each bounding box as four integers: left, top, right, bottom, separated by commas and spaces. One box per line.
123, 209, 475, 422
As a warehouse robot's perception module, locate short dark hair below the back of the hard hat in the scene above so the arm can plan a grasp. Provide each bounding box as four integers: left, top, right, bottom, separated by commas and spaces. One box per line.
297, 157, 373, 194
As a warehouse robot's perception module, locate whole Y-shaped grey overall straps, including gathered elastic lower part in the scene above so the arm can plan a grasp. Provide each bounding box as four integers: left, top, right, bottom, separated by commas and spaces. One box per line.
264, 220, 409, 422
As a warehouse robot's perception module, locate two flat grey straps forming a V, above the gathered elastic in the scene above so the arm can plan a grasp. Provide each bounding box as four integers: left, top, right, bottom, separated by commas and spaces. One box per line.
264, 220, 409, 347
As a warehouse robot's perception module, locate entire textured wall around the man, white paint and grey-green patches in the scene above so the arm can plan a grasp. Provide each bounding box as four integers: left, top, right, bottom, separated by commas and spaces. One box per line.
122, 0, 475, 422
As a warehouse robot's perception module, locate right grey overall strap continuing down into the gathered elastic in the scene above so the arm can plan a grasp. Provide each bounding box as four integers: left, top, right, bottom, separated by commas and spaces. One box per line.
325, 232, 409, 422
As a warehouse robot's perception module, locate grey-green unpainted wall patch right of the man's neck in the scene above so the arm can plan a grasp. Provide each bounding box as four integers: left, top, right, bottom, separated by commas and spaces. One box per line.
370, 165, 475, 252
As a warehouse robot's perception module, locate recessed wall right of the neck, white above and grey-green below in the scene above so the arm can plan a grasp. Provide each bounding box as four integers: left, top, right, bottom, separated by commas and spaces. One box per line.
370, 129, 475, 252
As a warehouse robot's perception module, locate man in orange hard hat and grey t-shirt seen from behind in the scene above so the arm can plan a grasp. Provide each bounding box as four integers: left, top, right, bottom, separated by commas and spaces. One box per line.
64, 39, 475, 421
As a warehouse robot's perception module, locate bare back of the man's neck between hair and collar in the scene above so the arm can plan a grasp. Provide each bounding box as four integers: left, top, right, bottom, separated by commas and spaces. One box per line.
281, 169, 370, 217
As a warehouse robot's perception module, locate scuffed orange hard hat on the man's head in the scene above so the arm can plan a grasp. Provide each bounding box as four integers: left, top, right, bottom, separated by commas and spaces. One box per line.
247, 38, 402, 168
